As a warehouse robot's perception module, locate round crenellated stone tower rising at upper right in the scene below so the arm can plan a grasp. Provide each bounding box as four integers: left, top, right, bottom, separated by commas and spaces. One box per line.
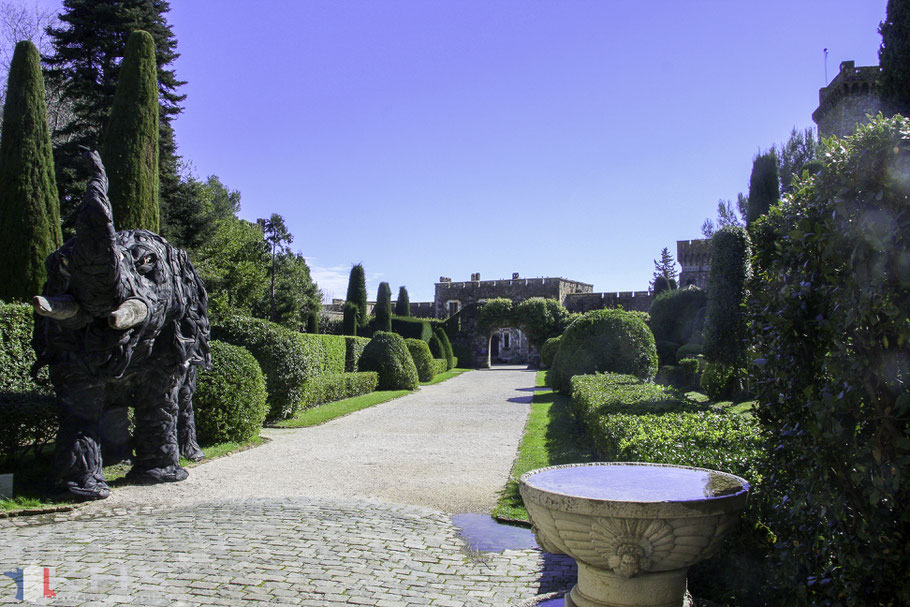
812, 61, 882, 137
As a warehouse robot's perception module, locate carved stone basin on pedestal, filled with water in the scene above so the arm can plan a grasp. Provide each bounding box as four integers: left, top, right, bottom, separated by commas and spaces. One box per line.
520, 462, 749, 607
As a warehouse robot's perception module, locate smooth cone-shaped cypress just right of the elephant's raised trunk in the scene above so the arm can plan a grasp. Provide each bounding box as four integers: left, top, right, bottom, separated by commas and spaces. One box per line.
101, 30, 160, 232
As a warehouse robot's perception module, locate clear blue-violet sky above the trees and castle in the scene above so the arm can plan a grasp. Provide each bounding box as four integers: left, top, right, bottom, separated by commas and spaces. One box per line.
35, 0, 886, 301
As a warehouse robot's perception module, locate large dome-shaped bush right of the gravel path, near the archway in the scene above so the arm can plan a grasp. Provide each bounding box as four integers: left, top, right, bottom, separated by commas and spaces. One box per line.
550, 309, 657, 392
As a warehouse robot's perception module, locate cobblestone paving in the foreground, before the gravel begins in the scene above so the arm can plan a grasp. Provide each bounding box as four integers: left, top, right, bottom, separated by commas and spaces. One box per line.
0, 371, 575, 607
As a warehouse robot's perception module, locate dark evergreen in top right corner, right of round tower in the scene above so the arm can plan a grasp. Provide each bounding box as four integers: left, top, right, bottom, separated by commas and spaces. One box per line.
878, 0, 910, 116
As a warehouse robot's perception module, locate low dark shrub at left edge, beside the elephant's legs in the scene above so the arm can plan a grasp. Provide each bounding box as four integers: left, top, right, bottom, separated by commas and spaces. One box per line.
0, 390, 60, 471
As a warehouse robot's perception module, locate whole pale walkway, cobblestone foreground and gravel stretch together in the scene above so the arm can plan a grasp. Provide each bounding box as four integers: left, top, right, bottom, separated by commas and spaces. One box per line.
0, 367, 574, 607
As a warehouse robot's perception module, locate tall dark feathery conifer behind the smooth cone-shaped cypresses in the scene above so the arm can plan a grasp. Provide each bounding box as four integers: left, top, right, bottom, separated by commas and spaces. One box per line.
45, 0, 186, 236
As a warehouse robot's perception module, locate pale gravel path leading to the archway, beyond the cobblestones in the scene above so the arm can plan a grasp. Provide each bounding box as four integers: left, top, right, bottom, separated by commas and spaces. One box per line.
84, 367, 535, 513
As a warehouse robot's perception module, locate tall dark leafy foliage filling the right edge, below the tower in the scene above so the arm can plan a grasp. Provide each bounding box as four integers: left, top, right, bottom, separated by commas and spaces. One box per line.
749, 117, 910, 605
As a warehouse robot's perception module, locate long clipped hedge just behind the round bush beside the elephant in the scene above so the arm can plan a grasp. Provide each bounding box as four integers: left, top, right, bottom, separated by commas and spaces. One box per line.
212, 316, 347, 420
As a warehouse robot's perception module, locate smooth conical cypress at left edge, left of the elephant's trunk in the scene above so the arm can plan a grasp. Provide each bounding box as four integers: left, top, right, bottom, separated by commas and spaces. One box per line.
0, 40, 63, 300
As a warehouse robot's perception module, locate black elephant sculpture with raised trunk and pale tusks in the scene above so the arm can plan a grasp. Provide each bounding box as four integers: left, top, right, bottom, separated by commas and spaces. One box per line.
33, 149, 210, 499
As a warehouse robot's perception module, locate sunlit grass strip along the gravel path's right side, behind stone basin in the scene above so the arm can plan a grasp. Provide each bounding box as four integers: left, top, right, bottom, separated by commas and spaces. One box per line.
493, 371, 597, 523
